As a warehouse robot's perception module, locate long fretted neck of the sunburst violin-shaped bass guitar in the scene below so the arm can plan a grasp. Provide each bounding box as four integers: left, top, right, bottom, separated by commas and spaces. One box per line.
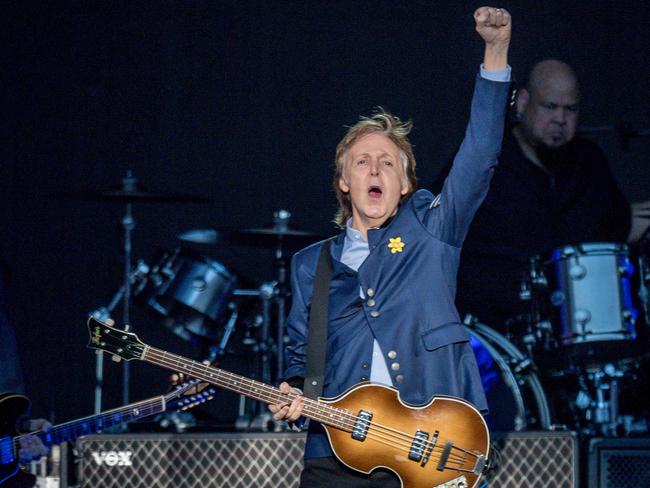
140, 346, 352, 432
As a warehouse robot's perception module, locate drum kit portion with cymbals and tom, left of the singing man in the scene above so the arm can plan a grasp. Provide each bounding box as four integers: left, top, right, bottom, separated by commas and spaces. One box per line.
51, 172, 321, 430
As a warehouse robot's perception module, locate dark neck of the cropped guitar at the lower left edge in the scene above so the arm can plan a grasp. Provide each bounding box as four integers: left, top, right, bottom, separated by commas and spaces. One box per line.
16, 396, 166, 446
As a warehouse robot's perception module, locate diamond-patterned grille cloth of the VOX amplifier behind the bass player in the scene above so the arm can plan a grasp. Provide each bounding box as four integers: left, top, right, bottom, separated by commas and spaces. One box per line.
77, 432, 577, 488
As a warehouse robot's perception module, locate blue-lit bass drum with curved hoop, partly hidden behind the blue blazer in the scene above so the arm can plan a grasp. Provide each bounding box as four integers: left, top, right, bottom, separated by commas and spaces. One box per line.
465, 316, 552, 431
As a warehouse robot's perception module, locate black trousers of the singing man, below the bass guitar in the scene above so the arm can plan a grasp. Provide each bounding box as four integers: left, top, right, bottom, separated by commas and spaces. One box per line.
300, 457, 402, 488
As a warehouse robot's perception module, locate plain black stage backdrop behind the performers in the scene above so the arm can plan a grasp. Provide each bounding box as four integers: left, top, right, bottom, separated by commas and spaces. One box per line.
5, 0, 650, 421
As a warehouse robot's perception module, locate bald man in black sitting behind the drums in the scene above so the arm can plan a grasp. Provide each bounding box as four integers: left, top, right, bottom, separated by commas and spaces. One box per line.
434, 59, 648, 335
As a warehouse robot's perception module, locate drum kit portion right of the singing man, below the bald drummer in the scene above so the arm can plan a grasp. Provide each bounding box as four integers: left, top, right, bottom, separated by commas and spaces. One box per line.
465, 241, 650, 436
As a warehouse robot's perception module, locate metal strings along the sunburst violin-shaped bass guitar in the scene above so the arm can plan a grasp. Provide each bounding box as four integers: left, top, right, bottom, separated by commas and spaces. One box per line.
143, 346, 474, 464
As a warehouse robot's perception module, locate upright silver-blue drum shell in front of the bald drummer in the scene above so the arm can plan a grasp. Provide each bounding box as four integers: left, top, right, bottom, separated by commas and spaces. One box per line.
549, 243, 637, 346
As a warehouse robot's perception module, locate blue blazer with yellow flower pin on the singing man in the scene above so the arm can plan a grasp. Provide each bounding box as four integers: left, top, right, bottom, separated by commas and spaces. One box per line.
285, 76, 509, 458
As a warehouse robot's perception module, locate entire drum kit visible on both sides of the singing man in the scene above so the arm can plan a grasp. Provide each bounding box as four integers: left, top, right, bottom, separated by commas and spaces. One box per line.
54, 173, 650, 436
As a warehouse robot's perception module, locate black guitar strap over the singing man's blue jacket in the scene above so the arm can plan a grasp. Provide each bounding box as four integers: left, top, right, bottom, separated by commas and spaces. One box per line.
303, 239, 332, 399
